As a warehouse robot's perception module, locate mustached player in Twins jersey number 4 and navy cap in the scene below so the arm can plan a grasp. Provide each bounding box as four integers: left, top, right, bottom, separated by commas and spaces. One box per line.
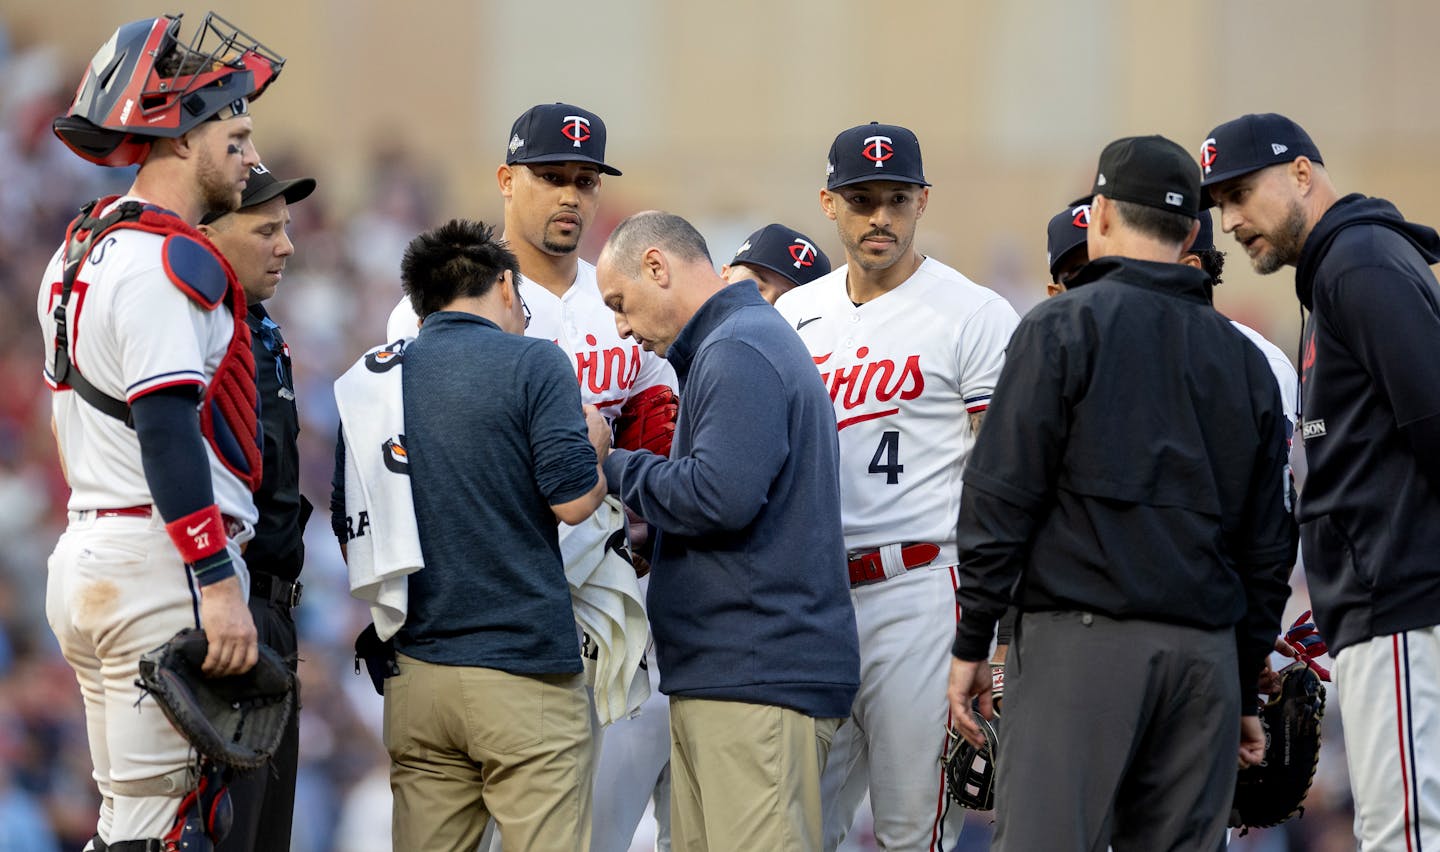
775, 124, 1018, 851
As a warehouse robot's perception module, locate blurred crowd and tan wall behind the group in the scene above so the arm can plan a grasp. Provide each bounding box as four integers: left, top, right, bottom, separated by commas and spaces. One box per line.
0, 0, 1440, 852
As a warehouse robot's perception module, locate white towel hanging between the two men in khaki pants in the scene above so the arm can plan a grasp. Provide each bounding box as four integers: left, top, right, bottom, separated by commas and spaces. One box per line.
560, 497, 649, 725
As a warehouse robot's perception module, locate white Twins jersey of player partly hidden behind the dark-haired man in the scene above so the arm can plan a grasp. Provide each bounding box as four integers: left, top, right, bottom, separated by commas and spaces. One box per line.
386, 260, 675, 422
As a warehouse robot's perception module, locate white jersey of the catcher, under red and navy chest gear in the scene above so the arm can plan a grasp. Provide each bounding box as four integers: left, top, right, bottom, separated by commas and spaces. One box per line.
36, 199, 258, 522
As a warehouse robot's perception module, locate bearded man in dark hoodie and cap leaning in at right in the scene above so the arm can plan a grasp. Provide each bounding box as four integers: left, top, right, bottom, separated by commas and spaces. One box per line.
1201, 114, 1440, 852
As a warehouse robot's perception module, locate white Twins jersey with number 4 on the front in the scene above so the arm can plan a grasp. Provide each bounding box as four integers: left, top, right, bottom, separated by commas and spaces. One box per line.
775, 258, 1020, 564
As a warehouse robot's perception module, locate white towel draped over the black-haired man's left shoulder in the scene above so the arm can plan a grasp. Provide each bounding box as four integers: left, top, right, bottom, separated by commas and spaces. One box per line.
336, 338, 425, 639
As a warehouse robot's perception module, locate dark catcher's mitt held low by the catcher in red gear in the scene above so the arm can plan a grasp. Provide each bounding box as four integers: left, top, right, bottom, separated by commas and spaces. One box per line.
135, 629, 295, 770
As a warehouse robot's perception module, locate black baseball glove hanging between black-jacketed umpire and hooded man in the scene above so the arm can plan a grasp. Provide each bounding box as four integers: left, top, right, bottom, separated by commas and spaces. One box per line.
1230, 661, 1325, 829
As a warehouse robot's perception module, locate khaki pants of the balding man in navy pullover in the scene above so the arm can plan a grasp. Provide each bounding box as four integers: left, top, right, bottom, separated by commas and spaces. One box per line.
670, 698, 841, 852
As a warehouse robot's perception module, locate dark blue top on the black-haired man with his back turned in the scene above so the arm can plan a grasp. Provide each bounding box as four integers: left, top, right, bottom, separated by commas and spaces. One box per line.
395, 311, 598, 675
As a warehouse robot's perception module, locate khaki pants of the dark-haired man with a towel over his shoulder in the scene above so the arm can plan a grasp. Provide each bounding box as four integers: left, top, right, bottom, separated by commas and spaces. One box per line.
384, 655, 595, 852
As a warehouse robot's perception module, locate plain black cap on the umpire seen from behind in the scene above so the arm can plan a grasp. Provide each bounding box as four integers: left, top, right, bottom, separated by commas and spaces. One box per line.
1092, 135, 1200, 219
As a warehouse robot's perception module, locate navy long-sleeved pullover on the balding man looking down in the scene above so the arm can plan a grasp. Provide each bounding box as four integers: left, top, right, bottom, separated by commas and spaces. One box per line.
605, 282, 860, 718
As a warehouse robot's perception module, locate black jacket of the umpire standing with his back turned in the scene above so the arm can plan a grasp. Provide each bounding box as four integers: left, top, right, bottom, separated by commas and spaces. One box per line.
955, 258, 1296, 712
